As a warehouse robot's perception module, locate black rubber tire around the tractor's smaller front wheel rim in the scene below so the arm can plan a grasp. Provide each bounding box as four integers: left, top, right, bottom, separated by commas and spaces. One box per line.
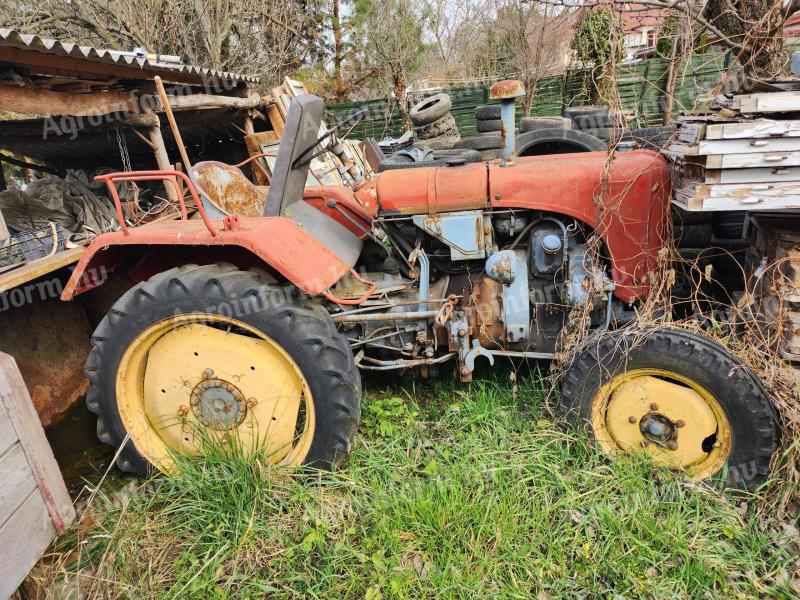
560, 328, 778, 490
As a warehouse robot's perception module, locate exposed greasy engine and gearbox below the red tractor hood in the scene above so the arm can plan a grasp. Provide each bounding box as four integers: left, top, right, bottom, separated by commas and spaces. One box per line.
334, 210, 622, 379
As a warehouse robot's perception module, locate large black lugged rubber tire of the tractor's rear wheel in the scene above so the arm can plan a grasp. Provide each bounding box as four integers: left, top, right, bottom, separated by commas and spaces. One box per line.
85, 264, 361, 476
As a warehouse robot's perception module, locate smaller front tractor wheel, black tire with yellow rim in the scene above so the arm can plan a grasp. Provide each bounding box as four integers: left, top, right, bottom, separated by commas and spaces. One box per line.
561, 328, 778, 489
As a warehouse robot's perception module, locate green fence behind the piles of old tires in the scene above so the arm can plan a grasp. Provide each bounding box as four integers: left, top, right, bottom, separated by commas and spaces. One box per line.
327, 52, 730, 139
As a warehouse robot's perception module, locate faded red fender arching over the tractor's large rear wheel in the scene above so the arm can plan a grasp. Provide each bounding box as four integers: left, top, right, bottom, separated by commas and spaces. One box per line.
61, 217, 353, 300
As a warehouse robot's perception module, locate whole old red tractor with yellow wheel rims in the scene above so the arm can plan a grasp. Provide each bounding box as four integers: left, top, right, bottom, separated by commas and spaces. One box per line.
63, 82, 778, 487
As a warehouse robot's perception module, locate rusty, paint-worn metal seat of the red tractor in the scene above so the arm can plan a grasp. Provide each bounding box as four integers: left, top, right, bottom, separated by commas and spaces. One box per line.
189, 160, 267, 219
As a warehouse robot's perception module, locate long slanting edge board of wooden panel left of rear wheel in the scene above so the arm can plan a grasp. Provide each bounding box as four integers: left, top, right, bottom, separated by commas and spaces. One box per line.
0, 352, 75, 533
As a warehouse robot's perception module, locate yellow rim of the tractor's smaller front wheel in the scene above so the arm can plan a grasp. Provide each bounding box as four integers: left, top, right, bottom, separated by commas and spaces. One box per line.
591, 369, 731, 480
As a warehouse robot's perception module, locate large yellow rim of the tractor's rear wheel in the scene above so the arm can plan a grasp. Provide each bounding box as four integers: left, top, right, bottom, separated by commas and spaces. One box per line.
116, 314, 316, 471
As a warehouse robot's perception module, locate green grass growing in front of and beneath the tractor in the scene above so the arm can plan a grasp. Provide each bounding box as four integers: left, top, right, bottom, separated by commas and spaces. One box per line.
45, 378, 800, 599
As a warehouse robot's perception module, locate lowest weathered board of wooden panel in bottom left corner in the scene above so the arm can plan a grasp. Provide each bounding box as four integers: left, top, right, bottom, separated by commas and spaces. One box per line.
0, 490, 56, 598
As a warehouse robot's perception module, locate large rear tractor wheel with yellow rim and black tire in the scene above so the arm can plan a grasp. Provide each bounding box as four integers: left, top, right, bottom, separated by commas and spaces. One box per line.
86, 265, 361, 475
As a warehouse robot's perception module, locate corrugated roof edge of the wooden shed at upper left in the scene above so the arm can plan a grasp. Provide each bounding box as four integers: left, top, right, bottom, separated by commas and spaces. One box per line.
0, 28, 260, 83
